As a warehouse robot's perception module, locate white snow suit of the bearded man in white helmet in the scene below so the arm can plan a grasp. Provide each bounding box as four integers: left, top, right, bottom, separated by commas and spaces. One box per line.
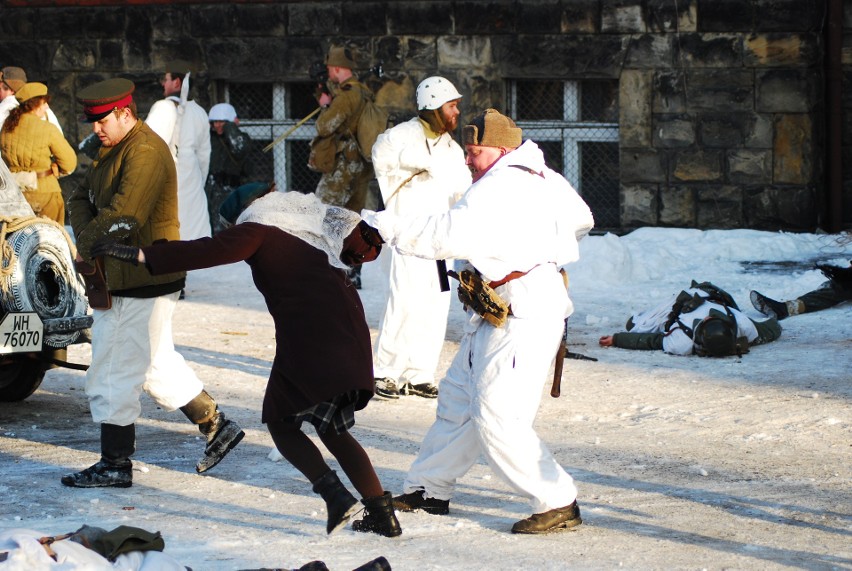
373, 117, 470, 385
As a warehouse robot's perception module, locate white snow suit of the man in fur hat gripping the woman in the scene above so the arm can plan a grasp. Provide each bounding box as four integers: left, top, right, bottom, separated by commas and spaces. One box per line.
364, 141, 593, 513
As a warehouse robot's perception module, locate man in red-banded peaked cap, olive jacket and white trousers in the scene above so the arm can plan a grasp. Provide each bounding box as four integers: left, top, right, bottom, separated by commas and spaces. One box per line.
62, 78, 244, 488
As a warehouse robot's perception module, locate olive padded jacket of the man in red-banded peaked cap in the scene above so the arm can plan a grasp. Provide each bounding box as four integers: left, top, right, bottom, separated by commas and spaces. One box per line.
68, 120, 186, 297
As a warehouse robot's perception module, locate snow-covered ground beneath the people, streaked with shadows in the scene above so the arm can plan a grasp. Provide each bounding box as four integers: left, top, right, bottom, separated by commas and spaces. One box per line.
0, 229, 852, 571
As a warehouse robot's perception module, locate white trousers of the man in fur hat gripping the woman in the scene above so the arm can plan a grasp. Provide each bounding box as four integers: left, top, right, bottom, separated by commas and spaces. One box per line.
404, 316, 577, 513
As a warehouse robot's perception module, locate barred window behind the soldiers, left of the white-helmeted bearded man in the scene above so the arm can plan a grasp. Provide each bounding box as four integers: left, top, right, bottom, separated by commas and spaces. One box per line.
219, 82, 320, 193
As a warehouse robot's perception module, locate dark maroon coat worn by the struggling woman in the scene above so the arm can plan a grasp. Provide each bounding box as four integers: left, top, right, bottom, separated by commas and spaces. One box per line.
143, 222, 374, 423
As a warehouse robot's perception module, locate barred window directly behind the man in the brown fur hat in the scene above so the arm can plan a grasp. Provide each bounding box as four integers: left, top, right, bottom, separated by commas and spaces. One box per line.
508, 79, 621, 230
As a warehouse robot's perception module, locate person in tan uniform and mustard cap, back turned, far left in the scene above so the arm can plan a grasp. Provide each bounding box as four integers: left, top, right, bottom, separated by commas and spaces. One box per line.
0, 82, 77, 224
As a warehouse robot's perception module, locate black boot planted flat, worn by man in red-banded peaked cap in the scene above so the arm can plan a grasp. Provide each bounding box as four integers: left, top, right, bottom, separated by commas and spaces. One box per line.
62, 423, 136, 488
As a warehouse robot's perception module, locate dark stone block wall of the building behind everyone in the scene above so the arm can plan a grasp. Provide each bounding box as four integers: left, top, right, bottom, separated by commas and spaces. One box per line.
0, 0, 852, 231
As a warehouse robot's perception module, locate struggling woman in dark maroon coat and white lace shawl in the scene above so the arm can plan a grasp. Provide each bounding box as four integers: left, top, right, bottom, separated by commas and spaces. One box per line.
92, 190, 402, 537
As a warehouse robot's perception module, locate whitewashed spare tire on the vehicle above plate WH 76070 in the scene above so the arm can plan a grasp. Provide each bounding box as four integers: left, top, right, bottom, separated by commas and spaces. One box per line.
0, 221, 88, 347
